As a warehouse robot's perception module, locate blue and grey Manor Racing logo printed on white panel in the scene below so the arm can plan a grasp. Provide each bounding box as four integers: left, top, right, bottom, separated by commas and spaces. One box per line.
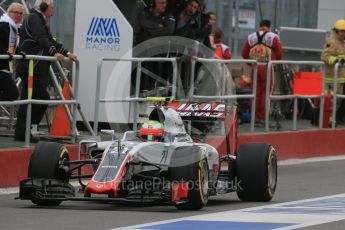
85, 17, 121, 52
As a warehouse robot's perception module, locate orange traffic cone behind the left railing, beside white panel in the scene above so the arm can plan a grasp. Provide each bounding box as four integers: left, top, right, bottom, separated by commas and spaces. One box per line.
49, 81, 71, 136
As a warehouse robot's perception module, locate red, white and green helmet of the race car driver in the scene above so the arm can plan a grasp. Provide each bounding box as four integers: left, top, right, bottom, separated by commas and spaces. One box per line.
139, 120, 164, 142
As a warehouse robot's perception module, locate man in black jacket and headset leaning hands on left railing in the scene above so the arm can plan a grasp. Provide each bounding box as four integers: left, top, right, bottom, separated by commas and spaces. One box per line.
15, 0, 77, 141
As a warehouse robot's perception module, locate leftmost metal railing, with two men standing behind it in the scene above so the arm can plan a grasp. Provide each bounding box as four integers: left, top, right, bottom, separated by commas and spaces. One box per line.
0, 55, 79, 147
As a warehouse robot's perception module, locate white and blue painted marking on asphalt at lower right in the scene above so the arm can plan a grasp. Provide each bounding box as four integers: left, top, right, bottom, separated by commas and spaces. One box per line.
110, 194, 345, 230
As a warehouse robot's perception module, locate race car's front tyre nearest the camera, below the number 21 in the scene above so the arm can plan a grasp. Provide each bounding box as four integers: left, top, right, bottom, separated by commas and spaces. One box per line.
169, 146, 209, 210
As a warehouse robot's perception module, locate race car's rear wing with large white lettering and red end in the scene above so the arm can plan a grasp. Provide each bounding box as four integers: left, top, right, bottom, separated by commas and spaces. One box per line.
168, 102, 226, 119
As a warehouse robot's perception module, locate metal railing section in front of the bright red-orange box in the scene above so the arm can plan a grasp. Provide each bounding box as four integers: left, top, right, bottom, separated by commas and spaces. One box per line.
265, 60, 325, 131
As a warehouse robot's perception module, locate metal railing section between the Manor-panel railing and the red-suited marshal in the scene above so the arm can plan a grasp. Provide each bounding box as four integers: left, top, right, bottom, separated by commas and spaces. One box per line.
190, 58, 258, 132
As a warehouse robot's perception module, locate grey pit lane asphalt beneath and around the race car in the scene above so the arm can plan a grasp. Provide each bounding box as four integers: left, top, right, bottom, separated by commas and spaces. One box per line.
0, 160, 345, 230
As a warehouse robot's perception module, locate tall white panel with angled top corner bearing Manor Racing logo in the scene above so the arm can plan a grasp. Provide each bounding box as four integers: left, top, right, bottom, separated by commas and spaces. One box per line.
74, 0, 133, 123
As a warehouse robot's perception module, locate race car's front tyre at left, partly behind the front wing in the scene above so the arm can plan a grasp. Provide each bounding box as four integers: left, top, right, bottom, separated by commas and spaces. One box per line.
28, 142, 70, 206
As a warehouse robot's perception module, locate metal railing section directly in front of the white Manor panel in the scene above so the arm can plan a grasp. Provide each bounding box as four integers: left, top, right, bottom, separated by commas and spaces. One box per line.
93, 57, 177, 133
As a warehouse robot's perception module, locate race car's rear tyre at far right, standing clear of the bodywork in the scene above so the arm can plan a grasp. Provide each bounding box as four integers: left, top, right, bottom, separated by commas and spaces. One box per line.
236, 143, 278, 202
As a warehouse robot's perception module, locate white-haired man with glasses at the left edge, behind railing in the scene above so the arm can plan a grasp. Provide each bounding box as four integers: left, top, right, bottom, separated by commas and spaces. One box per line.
0, 3, 24, 101
